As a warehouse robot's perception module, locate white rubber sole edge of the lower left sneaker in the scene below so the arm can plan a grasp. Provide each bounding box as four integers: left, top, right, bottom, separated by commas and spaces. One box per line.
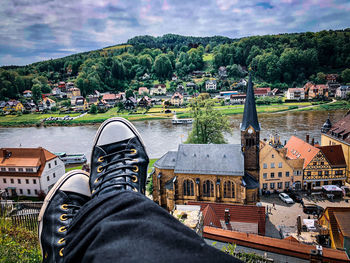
38, 170, 89, 254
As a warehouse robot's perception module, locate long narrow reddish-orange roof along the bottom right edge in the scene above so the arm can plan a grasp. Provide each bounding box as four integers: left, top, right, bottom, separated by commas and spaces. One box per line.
203, 226, 350, 263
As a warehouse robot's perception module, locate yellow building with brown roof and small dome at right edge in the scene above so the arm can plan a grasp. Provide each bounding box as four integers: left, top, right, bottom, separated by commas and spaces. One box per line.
321, 112, 350, 183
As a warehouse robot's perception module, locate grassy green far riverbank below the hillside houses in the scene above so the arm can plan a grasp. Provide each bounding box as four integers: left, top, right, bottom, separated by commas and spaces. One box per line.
0, 101, 350, 127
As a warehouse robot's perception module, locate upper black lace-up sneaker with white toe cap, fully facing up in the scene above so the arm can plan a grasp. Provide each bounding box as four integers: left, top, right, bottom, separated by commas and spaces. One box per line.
90, 117, 149, 198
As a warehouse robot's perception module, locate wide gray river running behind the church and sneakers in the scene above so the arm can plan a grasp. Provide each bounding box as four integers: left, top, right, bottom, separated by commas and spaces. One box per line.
0, 110, 346, 161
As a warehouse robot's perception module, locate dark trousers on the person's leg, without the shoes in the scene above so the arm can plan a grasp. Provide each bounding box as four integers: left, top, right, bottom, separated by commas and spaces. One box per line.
64, 191, 240, 263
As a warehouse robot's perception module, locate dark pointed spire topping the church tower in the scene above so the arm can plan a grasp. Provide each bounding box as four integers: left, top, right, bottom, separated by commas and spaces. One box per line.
241, 73, 260, 131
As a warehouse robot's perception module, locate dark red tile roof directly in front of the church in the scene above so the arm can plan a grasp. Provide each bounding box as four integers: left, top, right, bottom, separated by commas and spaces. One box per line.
188, 201, 266, 235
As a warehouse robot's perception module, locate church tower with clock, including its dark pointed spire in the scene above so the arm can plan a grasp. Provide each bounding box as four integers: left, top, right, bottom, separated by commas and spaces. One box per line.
241, 74, 260, 181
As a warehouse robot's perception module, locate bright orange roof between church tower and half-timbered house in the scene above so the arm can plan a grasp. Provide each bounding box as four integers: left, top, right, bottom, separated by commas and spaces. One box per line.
284, 136, 320, 168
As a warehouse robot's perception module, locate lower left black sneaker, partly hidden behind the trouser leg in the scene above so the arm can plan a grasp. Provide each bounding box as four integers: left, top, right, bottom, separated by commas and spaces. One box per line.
38, 170, 91, 262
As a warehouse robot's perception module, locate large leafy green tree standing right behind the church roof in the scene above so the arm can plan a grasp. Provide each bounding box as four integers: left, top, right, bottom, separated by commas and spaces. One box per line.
186, 98, 231, 144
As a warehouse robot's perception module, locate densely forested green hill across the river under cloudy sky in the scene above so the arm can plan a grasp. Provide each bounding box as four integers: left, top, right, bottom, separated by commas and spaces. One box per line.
0, 29, 350, 100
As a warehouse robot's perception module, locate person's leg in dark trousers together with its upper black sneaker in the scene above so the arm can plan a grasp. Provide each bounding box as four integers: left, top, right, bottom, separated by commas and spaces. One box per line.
65, 118, 241, 263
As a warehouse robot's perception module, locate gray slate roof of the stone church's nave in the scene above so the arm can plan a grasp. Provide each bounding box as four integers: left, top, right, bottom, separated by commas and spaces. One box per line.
174, 144, 244, 176
